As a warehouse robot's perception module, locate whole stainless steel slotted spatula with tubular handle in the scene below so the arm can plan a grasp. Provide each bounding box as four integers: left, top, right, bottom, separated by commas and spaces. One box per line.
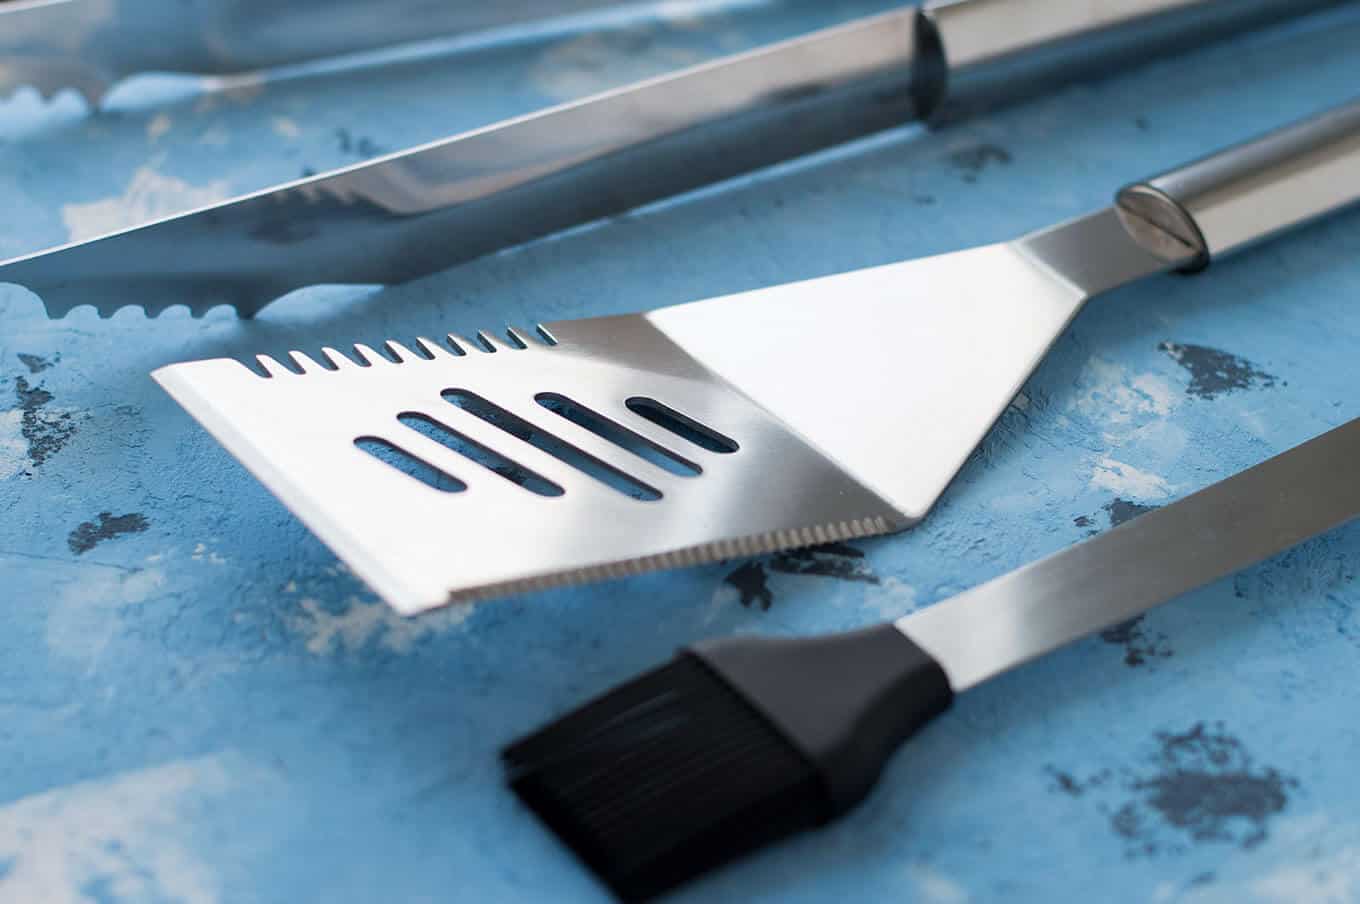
155, 101, 1360, 613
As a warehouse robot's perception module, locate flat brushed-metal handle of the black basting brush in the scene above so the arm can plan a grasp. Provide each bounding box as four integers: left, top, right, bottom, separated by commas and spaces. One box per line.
896, 419, 1360, 692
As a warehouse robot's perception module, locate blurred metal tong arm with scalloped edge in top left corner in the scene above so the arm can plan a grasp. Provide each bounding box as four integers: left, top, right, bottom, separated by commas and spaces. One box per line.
0, 0, 622, 103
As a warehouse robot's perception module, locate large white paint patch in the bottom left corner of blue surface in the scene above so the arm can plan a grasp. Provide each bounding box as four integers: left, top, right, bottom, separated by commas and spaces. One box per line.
0, 756, 233, 904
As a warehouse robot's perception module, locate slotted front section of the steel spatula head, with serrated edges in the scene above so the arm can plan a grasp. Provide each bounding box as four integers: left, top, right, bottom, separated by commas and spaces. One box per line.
154, 315, 902, 614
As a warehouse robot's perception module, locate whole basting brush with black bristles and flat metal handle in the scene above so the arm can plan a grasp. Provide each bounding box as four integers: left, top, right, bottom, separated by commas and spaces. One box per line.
503, 419, 1360, 901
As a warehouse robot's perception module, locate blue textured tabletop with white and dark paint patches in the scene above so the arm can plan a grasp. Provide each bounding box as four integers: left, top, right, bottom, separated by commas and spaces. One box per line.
0, 1, 1360, 904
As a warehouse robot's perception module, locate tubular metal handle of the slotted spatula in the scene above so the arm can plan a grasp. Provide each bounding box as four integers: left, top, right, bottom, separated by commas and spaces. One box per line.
1117, 99, 1360, 271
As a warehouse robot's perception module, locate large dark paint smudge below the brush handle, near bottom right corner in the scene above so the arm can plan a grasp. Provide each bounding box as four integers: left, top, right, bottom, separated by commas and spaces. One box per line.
1111, 722, 1297, 854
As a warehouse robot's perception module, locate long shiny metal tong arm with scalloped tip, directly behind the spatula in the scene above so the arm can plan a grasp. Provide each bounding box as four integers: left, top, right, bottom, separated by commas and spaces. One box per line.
0, 0, 1342, 317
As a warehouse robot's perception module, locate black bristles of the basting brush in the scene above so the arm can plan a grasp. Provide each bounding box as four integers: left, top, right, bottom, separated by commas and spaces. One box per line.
503, 654, 827, 901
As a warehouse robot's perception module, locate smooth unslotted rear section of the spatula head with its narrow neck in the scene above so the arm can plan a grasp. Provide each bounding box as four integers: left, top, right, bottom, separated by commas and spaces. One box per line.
647, 209, 1168, 513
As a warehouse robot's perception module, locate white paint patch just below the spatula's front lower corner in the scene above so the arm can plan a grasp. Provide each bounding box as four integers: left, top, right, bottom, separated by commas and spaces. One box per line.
288, 597, 475, 657
